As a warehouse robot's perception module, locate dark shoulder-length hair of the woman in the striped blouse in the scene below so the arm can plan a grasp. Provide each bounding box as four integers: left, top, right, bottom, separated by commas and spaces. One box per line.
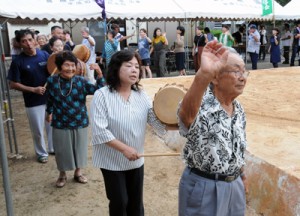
106, 50, 142, 91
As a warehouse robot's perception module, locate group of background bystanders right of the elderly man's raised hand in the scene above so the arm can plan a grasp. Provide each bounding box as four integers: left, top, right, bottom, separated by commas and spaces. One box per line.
220, 21, 300, 70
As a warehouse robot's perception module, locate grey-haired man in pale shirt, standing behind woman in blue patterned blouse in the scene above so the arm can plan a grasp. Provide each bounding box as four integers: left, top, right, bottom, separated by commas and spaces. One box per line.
81, 27, 96, 84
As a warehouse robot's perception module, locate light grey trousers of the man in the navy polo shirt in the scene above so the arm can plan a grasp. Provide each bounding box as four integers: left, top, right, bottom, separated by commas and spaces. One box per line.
26, 105, 53, 157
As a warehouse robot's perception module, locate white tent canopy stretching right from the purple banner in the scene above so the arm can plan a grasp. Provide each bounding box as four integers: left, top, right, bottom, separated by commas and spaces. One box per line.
105, 0, 300, 20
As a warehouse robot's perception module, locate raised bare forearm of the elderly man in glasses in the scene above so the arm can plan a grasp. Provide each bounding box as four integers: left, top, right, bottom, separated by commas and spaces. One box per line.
179, 69, 212, 128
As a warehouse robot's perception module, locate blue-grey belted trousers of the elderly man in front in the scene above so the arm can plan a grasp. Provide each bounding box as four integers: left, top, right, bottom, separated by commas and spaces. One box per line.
178, 168, 246, 216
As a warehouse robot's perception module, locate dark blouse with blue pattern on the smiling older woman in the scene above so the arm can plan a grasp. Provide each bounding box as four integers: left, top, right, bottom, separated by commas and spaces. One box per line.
46, 75, 104, 129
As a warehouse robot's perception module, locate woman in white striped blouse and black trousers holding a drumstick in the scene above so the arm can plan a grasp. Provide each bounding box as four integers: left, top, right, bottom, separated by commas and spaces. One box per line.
91, 50, 165, 216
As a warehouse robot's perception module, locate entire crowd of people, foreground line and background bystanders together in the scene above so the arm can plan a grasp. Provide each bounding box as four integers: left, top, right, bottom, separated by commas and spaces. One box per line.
7, 20, 300, 216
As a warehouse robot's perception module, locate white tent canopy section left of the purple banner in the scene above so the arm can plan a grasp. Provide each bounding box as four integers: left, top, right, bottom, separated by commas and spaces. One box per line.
0, 0, 102, 21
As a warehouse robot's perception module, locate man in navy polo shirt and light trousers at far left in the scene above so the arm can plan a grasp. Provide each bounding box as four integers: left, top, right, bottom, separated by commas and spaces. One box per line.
8, 29, 54, 163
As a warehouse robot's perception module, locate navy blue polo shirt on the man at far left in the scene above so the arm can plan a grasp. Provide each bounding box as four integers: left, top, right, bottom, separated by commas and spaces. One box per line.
7, 49, 49, 107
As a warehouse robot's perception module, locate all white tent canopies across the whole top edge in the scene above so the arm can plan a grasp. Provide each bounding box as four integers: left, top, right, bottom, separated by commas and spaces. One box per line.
0, 0, 300, 21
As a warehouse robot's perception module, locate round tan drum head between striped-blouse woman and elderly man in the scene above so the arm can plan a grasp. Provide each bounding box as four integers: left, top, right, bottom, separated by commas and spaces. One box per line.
153, 84, 187, 125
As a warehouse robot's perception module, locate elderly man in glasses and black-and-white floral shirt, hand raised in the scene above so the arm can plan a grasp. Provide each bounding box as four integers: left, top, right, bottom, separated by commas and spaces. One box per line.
178, 41, 249, 216
